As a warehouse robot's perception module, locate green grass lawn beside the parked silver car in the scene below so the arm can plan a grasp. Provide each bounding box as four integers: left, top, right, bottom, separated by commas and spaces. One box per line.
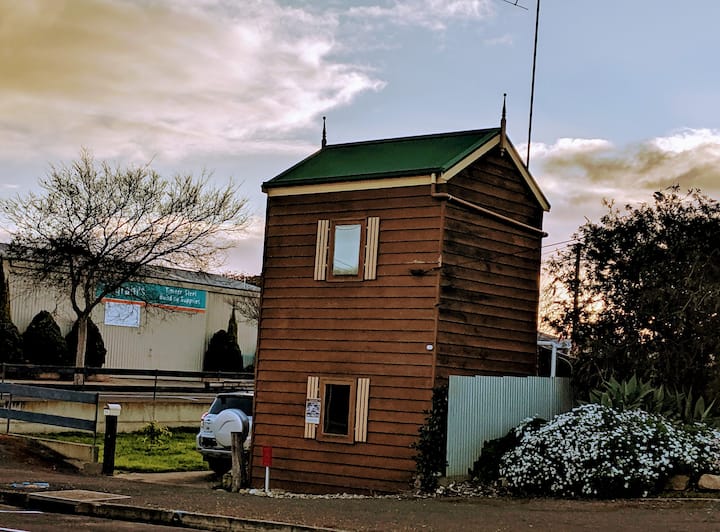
43, 427, 208, 473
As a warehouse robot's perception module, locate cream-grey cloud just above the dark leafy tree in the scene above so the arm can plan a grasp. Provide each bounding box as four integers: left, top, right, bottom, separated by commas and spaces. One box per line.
532, 129, 720, 251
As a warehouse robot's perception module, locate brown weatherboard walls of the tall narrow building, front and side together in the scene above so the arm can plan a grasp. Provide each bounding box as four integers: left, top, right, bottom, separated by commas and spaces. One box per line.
253, 134, 547, 492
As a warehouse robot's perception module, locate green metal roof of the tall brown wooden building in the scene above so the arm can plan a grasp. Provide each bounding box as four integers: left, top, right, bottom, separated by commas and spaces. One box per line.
263, 128, 500, 188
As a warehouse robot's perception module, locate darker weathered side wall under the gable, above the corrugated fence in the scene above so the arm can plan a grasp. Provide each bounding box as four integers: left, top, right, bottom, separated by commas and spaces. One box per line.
438, 152, 543, 377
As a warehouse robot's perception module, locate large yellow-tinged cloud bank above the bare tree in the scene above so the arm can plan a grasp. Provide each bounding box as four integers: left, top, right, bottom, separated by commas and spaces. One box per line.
0, 0, 383, 160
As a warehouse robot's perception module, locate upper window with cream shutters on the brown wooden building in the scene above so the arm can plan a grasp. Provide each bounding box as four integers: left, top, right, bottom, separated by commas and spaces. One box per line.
314, 217, 380, 281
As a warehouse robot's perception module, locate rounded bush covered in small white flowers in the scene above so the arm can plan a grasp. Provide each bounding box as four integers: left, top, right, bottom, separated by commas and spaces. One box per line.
500, 404, 720, 498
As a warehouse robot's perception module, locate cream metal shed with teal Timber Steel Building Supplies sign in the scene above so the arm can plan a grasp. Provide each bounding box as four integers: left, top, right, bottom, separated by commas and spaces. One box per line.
0, 244, 260, 371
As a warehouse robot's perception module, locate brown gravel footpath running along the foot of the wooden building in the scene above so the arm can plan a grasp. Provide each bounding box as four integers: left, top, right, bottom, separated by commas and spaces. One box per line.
0, 435, 720, 532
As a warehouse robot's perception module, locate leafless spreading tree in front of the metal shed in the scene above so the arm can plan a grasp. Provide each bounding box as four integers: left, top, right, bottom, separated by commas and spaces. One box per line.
0, 150, 248, 383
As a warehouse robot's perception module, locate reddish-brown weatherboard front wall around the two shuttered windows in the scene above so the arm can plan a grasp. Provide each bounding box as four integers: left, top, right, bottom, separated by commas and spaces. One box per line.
254, 186, 440, 491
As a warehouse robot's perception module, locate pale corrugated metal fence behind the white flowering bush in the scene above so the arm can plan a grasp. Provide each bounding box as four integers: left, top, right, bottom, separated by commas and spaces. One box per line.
447, 376, 572, 477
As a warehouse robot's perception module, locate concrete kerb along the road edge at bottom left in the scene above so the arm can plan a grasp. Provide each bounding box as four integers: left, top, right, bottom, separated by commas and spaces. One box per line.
0, 489, 343, 532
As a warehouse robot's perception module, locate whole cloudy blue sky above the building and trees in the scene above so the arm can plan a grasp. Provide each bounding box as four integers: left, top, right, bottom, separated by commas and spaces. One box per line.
0, 0, 720, 274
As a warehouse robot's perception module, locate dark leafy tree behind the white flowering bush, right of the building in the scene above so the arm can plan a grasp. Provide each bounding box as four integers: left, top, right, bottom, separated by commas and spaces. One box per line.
548, 188, 720, 396
